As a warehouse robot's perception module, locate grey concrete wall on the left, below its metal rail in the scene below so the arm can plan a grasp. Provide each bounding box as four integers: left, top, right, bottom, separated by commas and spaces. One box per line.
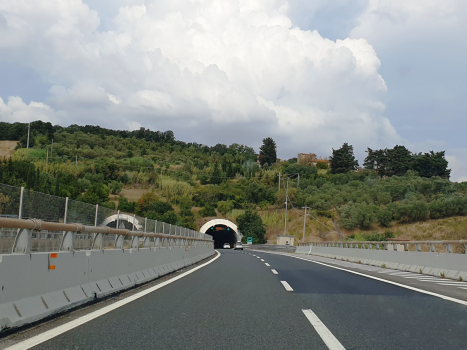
0, 244, 214, 330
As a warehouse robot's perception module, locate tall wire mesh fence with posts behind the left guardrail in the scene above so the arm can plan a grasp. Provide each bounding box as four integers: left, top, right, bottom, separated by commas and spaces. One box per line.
0, 184, 212, 254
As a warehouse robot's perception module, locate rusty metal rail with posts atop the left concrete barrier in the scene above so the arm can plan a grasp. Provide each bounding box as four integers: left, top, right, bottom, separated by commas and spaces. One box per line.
0, 218, 214, 253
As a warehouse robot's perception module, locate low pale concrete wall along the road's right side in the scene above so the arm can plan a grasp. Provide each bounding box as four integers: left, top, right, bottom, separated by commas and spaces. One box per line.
296, 246, 467, 281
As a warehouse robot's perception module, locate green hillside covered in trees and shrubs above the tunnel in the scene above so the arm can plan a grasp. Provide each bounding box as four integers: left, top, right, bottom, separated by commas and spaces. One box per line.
0, 122, 467, 242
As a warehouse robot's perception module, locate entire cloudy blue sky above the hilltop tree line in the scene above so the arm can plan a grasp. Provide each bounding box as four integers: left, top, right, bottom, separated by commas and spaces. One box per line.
0, 0, 467, 181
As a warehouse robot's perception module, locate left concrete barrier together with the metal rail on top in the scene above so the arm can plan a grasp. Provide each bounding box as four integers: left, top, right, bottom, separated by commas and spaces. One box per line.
0, 218, 214, 330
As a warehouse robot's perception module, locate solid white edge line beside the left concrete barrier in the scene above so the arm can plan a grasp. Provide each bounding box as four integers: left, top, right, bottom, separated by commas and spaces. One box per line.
5, 250, 221, 350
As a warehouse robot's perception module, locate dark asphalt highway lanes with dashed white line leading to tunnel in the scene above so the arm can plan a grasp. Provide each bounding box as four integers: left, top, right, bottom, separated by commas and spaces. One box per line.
7, 250, 467, 349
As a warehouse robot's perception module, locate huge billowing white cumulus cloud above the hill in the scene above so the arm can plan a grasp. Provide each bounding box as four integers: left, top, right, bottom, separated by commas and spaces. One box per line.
0, 0, 400, 156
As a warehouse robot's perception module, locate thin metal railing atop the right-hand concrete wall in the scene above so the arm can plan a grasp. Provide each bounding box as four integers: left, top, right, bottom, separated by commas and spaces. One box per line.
298, 240, 467, 254
